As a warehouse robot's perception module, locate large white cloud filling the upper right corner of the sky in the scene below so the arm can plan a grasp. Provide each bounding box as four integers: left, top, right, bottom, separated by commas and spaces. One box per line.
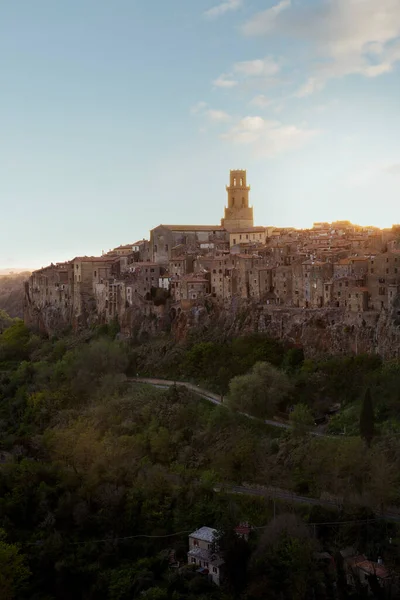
242, 0, 400, 97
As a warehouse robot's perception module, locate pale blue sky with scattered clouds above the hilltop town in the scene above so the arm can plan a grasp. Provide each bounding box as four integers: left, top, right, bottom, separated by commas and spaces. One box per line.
0, 0, 400, 269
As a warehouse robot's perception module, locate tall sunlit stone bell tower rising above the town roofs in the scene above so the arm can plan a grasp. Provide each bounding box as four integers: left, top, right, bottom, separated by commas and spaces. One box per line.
221, 169, 253, 231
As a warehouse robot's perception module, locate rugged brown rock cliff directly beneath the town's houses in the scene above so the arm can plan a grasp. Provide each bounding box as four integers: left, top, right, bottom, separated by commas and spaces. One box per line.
25, 284, 400, 359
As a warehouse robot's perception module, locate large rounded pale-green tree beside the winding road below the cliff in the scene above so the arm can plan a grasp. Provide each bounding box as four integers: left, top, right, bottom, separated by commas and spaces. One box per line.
228, 362, 292, 418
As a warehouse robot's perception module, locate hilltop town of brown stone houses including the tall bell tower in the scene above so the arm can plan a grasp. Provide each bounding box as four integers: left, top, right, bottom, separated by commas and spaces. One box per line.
26, 170, 400, 322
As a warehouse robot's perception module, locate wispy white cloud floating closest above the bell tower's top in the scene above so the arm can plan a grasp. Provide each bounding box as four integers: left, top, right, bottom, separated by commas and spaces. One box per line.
221, 117, 318, 157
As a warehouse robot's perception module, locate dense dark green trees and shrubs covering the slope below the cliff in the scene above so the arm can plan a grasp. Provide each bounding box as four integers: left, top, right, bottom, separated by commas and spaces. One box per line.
0, 320, 400, 600
